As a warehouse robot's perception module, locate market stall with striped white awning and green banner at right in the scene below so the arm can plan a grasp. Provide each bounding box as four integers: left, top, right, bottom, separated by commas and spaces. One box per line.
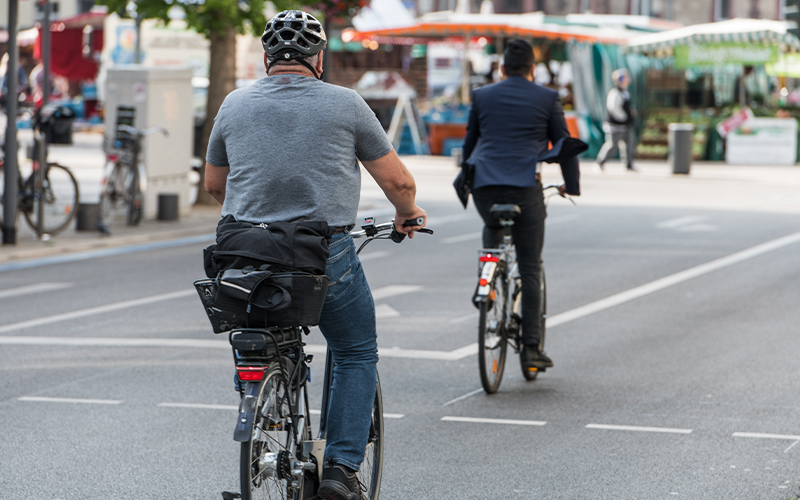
626, 19, 800, 163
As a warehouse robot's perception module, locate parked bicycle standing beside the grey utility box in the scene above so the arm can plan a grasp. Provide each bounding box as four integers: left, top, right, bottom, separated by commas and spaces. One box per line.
99, 124, 169, 230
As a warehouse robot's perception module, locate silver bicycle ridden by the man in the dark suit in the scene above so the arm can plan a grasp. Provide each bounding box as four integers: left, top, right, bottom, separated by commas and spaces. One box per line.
473, 184, 575, 394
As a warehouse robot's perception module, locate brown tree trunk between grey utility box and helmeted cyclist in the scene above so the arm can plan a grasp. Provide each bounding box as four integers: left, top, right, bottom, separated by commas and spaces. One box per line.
197, 21, 236, 205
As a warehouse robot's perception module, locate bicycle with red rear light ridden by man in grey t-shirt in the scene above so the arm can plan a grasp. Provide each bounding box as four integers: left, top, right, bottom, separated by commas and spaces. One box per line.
195, 217, 433, 500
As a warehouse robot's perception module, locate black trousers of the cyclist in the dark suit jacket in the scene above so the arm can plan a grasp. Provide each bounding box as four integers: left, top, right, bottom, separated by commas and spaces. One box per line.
472, 184, 547, 347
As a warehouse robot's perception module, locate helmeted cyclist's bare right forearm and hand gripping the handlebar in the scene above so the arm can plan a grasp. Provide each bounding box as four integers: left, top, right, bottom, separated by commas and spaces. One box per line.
361, 150, 427, 237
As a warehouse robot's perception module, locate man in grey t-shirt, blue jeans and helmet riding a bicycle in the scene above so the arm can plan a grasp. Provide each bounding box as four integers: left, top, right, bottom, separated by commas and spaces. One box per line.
205, 11, 426, 500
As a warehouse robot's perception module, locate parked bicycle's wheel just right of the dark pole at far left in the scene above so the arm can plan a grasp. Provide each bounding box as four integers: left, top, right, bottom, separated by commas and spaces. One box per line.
25, 163, 80, 235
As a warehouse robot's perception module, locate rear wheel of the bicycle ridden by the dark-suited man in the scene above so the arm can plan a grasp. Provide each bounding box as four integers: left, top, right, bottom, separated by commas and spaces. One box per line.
478, 267, 508, 394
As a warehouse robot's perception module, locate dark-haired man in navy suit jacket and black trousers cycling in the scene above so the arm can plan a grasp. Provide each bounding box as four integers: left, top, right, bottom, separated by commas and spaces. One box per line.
463, 40, 580, 369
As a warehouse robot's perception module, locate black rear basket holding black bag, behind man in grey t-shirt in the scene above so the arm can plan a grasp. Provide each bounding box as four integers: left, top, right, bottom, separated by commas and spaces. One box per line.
194, 215, 334, 333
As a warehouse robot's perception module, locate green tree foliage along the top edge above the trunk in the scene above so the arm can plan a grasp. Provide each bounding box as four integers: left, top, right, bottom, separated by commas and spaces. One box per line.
97, 0, 298, 37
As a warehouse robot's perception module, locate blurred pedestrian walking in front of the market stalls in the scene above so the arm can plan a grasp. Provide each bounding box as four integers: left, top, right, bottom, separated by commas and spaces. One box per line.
595, 69, 636, 172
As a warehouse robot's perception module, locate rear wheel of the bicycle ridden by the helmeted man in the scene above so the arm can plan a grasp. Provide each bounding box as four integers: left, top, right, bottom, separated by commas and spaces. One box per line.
239, 365, 308, 500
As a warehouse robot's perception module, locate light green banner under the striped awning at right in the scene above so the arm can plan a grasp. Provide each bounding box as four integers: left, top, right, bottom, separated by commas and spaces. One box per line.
673, 43, 779, 68
